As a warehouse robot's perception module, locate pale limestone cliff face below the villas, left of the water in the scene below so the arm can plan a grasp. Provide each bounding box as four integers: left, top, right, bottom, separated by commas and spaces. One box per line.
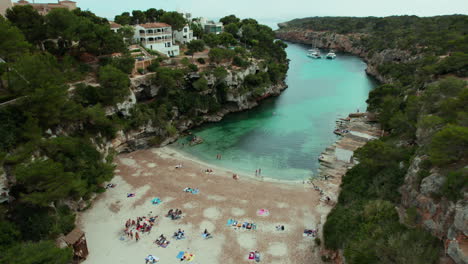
108, 62, 286, 152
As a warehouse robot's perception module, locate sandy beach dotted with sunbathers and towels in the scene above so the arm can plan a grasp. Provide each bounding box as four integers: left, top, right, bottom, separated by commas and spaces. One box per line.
79, 147, 330, 264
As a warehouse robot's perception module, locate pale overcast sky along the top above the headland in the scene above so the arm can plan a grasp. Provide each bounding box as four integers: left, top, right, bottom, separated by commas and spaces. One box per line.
33, 0, 468, 25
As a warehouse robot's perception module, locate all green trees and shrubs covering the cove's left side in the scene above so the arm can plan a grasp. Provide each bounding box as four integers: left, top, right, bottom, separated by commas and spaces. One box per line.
0, 6, 287, 264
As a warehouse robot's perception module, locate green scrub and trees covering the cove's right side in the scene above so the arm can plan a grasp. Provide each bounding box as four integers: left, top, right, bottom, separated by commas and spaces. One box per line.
280, 15, 468, 263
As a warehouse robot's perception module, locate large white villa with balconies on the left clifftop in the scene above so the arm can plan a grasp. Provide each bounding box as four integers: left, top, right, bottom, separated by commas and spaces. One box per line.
134, 23, 181, 57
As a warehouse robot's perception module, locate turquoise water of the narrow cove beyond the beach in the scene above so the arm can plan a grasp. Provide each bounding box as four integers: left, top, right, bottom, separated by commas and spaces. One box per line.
173, 43, 375, 180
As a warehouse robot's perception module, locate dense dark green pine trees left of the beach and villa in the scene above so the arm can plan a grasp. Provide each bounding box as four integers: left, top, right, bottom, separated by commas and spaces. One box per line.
0, 6, 126, 264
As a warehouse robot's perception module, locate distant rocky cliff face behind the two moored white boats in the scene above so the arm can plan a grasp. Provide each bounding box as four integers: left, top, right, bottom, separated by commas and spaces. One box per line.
276, 28, 414, 83
